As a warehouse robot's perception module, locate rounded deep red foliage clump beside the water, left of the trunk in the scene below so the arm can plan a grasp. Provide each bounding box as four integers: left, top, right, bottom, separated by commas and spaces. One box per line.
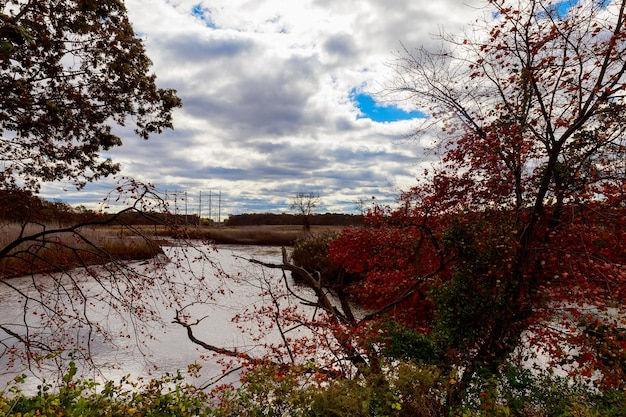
329, 202, 446, 329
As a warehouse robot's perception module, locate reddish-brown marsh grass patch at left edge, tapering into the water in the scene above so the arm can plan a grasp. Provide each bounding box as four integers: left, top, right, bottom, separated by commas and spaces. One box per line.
0, 223, 162, 278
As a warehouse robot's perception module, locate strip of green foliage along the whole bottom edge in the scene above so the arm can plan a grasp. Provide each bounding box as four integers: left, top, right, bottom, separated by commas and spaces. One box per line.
0, 358, 626, 417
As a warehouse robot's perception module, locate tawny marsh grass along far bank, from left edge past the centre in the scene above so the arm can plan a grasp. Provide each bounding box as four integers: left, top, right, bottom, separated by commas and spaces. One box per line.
0, 223, 342, 279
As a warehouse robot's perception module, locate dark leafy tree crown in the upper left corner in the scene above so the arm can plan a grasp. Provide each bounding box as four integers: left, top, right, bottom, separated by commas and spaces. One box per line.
0, 0, 181, 191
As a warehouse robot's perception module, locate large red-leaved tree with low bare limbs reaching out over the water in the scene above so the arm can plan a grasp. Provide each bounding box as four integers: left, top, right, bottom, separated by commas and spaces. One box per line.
171, 0, 626, 415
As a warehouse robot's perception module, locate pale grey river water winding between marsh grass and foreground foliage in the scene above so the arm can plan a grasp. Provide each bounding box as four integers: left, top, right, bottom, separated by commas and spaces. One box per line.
0, 240, 608, 392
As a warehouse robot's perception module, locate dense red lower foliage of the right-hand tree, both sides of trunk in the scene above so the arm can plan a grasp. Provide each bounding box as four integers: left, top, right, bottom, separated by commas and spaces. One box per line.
330, 190, 626, 386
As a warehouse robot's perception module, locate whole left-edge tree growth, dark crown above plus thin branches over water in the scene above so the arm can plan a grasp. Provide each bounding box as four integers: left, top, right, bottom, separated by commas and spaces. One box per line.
0, 0, 210, 376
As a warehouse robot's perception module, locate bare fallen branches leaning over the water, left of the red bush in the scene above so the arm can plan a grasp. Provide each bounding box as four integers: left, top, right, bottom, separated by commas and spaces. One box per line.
173, 248, 368, 383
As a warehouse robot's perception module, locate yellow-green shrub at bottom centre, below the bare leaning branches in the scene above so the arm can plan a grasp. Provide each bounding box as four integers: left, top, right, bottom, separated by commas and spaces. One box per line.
212, 361, 445, 417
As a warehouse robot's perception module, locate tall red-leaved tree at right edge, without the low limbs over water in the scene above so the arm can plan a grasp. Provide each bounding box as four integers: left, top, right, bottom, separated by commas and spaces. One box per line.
331, 0, 626, 404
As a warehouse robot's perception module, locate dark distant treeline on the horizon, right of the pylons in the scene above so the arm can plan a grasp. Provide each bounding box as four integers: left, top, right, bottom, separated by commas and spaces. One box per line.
226, 213, 363, 226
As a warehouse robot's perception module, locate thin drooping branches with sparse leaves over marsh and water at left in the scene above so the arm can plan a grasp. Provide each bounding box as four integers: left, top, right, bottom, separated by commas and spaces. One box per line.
0, 181, 217, 376
